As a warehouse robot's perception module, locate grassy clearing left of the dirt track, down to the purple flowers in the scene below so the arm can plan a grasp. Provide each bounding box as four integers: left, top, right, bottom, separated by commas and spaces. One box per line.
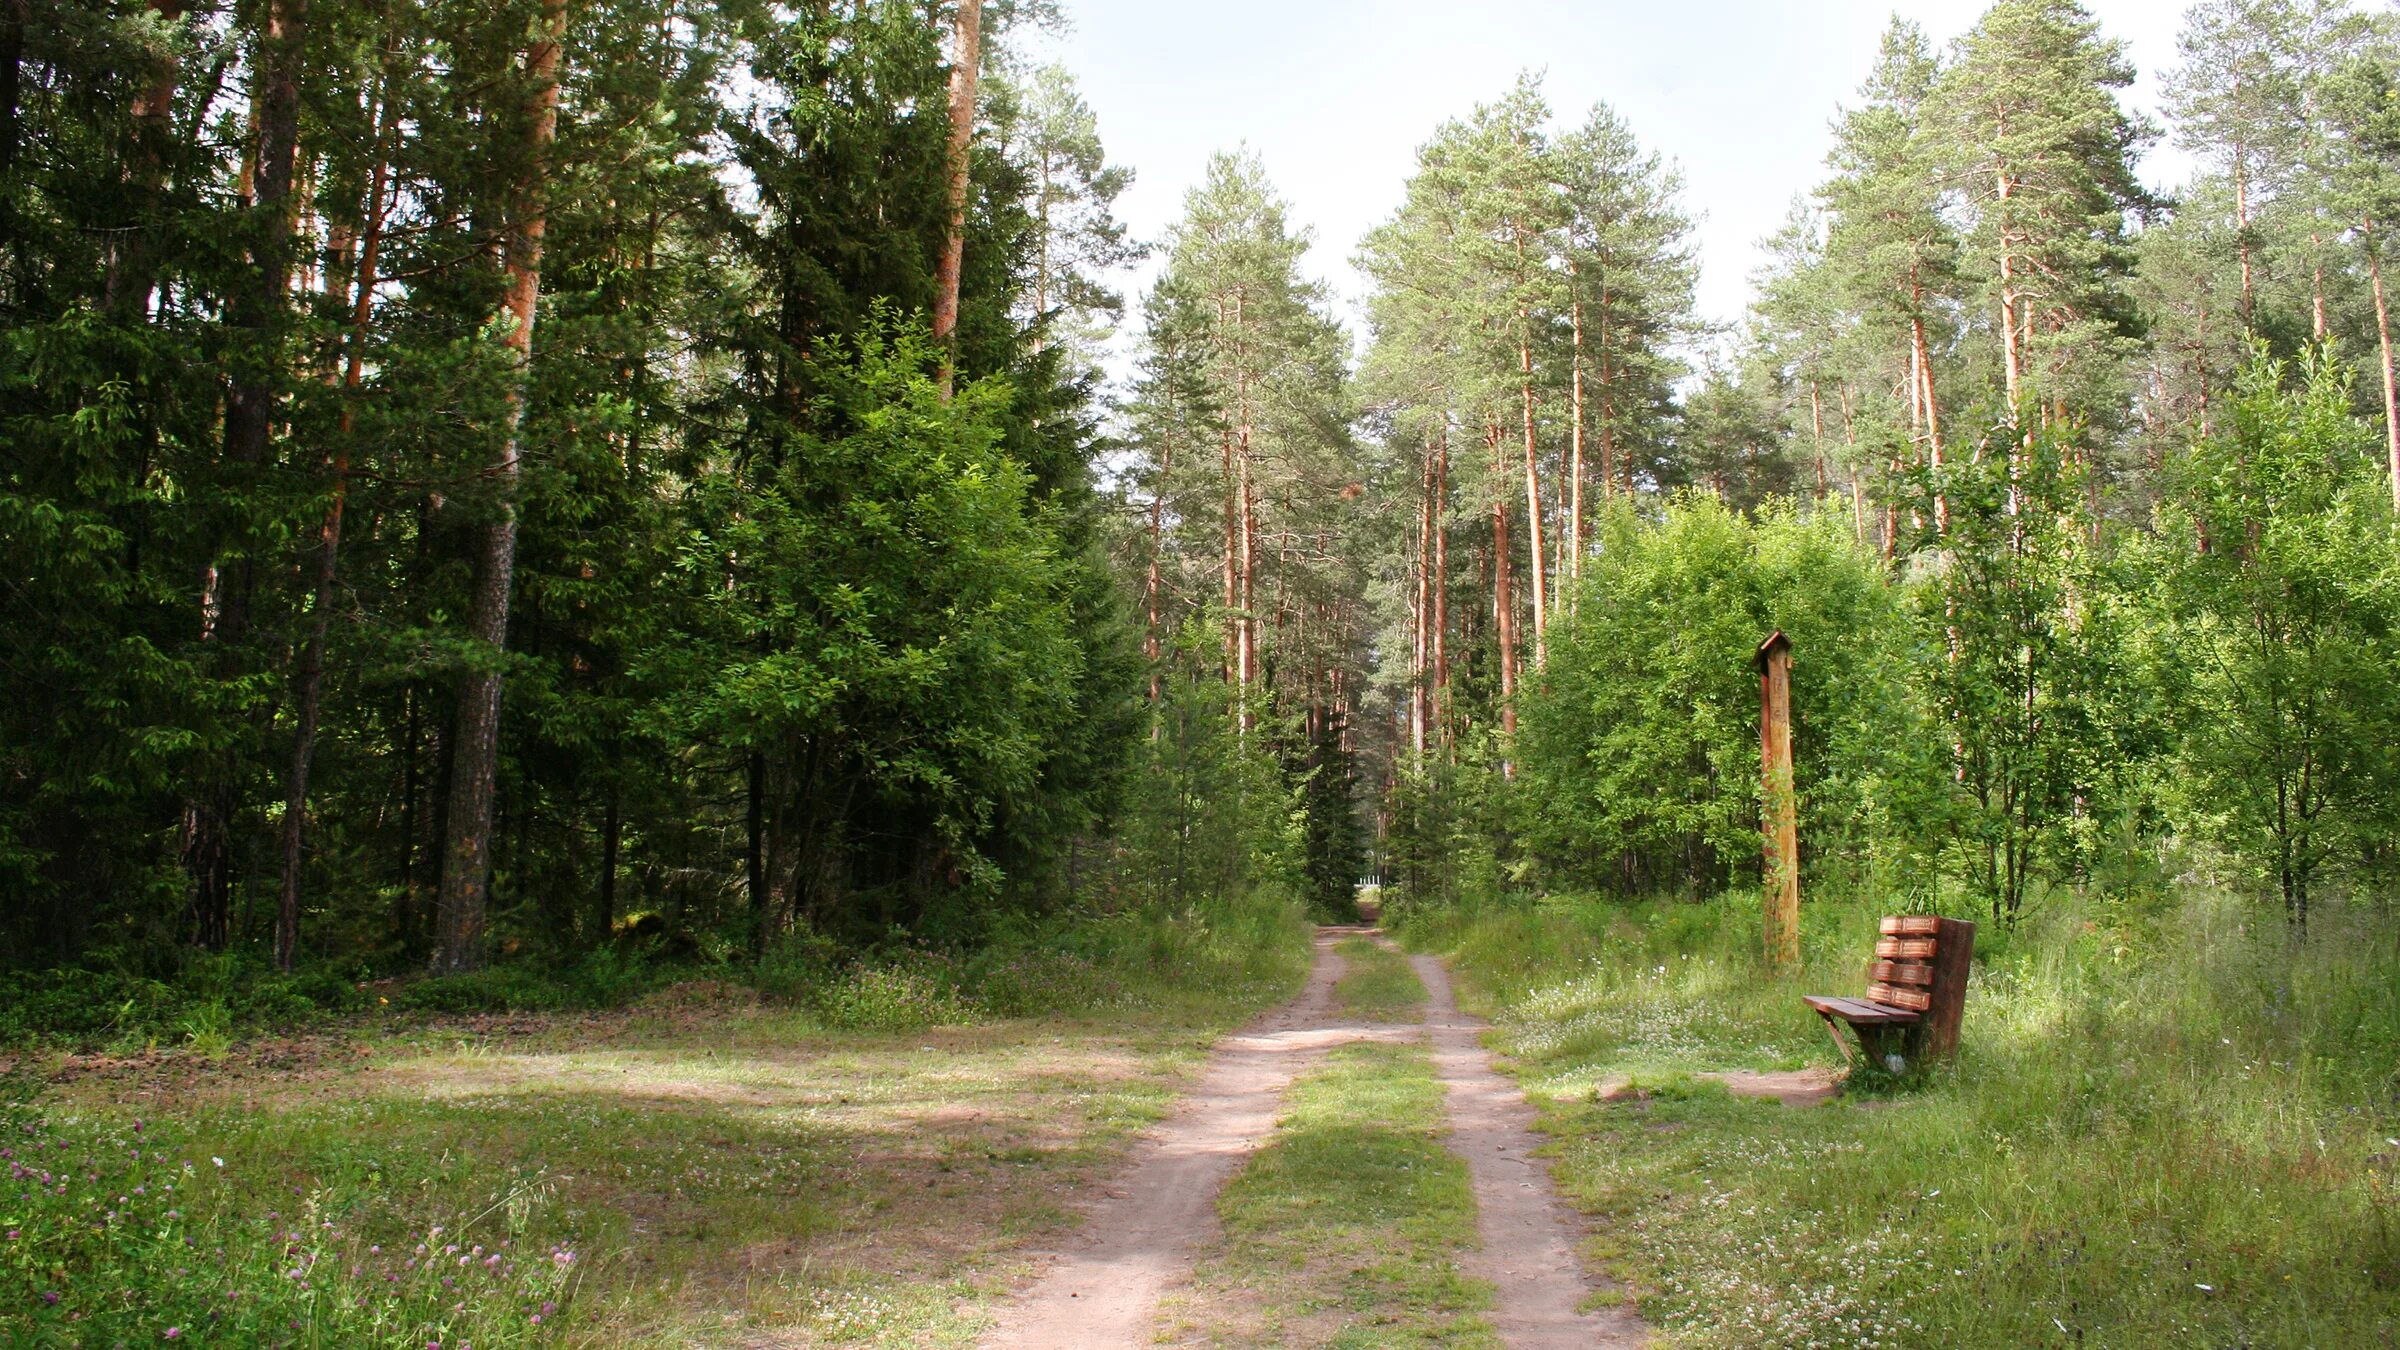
0, 906, 1308, 1350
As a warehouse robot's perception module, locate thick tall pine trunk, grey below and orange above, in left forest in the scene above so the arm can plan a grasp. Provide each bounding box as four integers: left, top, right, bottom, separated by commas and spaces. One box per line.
434, 0, 566, 970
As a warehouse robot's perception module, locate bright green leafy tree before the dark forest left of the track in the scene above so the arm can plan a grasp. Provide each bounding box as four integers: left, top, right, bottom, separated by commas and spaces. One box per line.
667, 319, 1082, 922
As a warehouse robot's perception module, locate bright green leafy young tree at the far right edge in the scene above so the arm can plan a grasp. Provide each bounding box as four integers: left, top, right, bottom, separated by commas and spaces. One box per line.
2143, 353, 2400, 922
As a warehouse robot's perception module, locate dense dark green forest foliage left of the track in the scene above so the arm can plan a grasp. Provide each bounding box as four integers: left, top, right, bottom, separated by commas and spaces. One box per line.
0, 0, 1140, 975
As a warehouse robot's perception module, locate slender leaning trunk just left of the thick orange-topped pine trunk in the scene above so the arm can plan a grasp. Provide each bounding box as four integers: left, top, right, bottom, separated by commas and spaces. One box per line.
276, 68, 394, 970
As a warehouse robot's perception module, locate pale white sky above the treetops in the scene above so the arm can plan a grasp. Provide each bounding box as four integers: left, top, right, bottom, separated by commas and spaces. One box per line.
1027, 0, 2189, 379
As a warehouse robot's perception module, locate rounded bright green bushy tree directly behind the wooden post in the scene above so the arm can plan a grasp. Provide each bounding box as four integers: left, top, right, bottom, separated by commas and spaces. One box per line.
1507, 495, 1939, 891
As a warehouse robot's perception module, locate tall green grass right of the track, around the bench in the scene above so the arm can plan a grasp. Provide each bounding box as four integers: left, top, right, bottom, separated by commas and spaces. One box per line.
1397, 889, 2400, 1348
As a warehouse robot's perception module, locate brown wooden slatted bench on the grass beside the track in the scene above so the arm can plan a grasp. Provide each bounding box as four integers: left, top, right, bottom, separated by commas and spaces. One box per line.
1800, 915, 1975, 1074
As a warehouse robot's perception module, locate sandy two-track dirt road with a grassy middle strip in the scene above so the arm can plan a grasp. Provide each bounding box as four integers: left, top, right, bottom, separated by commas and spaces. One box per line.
982, 927, 1644, 1350
